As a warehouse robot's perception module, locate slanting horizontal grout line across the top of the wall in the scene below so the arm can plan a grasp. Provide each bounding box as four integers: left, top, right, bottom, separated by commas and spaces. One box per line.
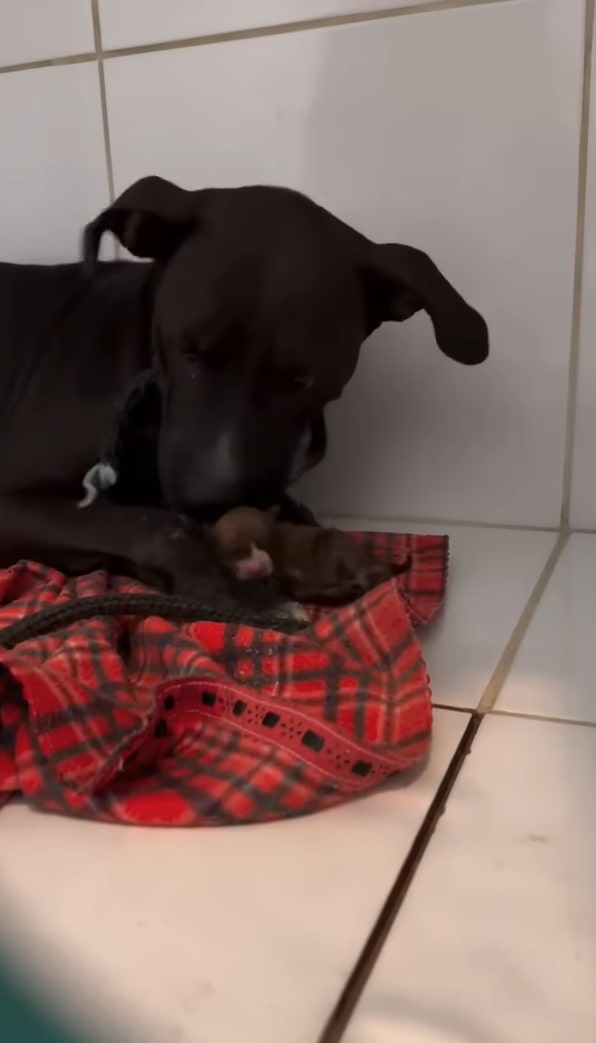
0, 0, 511, 75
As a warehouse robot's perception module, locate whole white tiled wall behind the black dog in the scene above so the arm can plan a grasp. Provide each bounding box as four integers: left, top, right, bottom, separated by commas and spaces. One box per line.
0, 0, 596, 528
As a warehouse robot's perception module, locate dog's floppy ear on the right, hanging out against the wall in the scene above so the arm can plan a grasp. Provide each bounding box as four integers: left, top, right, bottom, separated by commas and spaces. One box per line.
365, 243, 488, 366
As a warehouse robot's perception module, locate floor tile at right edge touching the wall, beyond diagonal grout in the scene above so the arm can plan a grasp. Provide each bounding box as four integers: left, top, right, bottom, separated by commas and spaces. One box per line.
497, 534, 596, 724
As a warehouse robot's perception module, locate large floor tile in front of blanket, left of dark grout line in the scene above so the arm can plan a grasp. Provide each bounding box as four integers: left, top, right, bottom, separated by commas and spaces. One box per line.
0, 711, 468, 1043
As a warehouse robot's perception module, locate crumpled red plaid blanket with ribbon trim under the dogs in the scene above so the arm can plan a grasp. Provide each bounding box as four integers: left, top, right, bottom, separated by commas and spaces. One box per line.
0, 533, 448, 826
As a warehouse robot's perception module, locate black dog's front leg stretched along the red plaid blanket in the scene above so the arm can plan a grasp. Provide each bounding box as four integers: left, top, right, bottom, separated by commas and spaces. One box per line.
0, 494, 305, 630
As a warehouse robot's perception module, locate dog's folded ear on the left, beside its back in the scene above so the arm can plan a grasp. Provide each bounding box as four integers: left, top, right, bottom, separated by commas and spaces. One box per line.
82, 176, 198, 274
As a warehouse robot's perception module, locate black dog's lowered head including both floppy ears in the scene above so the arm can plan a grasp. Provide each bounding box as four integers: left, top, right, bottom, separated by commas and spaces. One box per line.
85, 177, 488, 511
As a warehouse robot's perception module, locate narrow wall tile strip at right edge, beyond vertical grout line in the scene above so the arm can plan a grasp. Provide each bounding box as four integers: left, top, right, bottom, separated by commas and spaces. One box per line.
570, 12, 596, 529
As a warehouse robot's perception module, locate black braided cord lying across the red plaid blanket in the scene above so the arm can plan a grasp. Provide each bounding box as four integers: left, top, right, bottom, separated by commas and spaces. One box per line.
0, 593, 305, 649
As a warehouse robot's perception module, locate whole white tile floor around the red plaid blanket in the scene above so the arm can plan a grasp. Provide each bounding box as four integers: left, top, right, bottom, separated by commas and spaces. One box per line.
0, 526, 596, 1043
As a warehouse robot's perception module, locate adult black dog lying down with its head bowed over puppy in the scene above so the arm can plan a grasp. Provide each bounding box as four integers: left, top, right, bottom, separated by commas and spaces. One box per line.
0, 177, 488, 590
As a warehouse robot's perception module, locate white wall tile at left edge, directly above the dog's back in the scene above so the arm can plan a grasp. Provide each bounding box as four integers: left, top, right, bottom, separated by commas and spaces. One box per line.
0, 63, 108, 263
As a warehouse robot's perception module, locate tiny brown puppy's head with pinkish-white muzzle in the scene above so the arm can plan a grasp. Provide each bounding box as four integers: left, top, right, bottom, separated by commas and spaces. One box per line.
213, 507, 273, 580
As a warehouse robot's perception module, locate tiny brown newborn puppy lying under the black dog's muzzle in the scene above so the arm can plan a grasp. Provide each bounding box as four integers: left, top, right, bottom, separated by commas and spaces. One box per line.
213, 507, 411, 604
